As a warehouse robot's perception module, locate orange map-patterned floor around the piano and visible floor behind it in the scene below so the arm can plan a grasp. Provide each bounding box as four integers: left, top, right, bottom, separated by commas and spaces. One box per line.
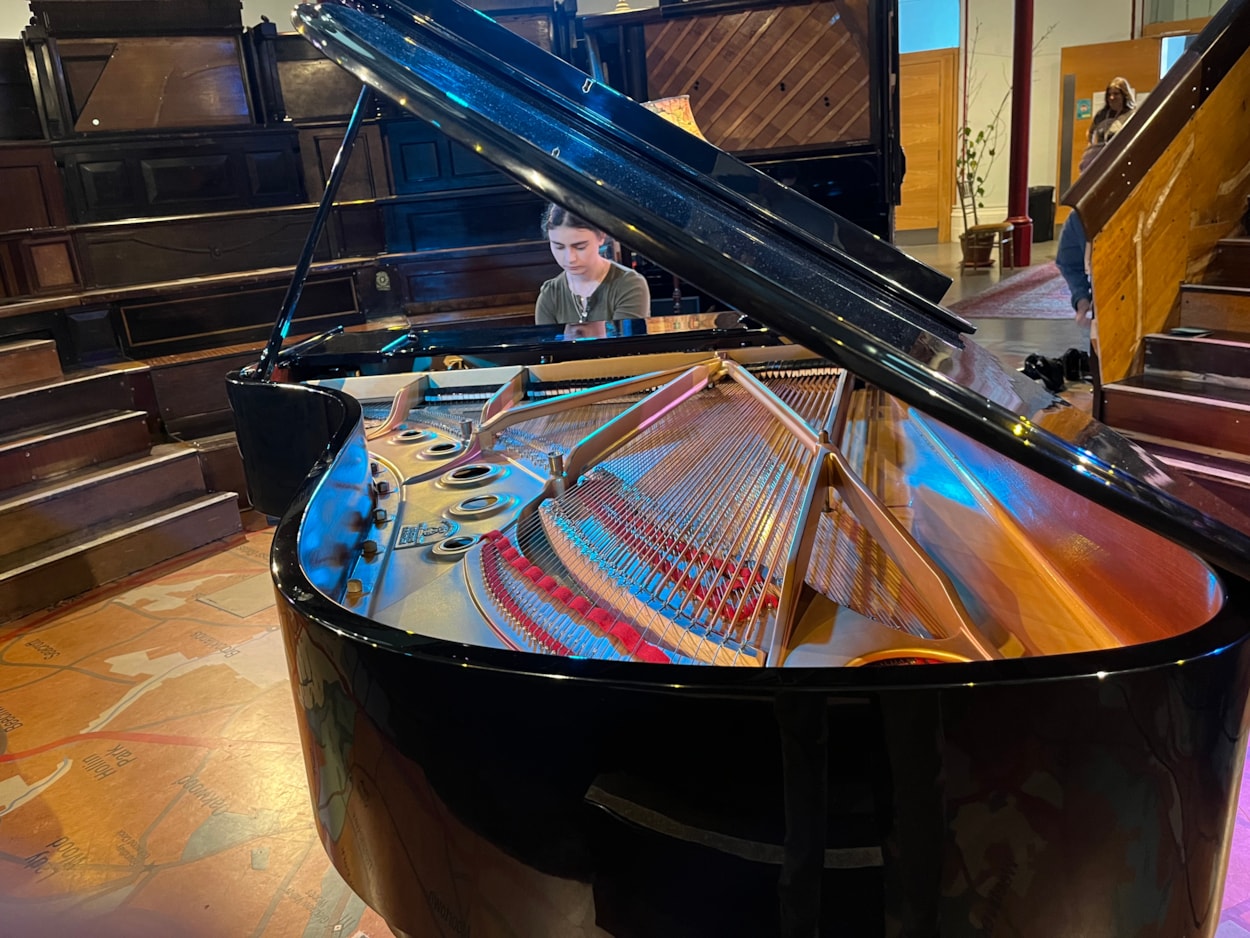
0, 243, 1250, 938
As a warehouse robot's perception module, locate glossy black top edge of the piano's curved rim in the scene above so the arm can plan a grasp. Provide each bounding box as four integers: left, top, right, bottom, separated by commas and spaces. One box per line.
270, 384, 1250, 697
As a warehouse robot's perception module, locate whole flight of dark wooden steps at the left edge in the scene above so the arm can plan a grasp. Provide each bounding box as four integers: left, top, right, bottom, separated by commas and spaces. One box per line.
0, 340, 241, 622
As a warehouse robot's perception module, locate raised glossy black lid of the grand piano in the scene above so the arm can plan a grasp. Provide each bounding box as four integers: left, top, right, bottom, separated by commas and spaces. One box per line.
293, 0, 1250, 577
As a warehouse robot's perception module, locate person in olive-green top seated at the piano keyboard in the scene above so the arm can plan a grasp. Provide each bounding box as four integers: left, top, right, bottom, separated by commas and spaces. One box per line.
534, 204, 651, 338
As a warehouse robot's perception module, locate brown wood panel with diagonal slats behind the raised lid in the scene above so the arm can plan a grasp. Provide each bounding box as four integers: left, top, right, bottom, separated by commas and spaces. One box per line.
646, 0, 870, 150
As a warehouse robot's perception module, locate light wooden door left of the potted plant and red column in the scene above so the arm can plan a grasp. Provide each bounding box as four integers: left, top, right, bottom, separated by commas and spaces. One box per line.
894, 49, 959, 241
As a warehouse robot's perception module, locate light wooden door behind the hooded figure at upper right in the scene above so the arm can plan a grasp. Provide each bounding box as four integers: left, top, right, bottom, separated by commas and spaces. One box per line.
1055, 39, 1161, 202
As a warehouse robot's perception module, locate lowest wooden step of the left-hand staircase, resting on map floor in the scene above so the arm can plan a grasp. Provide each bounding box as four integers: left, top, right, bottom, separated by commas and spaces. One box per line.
0, 492, 241, 622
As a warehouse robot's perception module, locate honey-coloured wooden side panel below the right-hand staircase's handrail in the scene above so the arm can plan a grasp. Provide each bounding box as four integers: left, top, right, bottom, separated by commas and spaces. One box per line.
1093, 42, 1250, 383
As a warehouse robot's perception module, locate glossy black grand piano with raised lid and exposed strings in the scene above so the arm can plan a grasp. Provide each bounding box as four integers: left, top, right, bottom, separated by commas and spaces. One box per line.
229, 0, 1250, 938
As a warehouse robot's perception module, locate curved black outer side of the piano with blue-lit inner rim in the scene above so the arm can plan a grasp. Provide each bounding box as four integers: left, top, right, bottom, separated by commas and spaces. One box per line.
273, 370, 1250, 938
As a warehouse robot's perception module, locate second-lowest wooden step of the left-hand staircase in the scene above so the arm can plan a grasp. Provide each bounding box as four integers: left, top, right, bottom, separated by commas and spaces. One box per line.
0, 446, 204, 568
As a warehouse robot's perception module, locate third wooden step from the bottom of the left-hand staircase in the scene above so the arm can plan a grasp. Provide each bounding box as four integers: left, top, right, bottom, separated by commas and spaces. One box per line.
0, 410, 151, 492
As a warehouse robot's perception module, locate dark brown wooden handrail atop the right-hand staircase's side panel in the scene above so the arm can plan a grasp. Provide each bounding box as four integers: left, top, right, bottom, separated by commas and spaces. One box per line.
1060, 0, 1250, 240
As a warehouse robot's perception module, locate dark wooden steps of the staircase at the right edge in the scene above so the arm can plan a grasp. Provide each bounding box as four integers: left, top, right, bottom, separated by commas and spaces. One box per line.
1101, 236, 1250, 515
